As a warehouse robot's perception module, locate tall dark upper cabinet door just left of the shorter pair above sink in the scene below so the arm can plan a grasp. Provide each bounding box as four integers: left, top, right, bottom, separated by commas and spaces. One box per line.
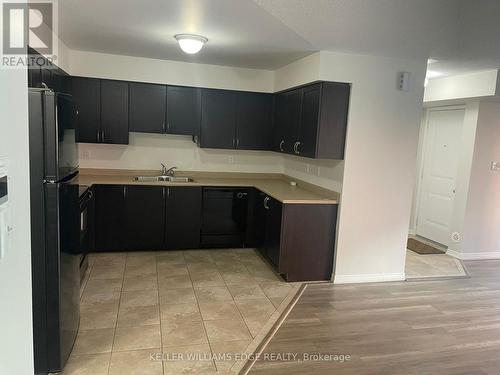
101, 80, 128, 144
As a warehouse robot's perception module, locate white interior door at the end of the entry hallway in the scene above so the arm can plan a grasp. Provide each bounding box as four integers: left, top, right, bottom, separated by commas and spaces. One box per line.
416, 109, 465, 245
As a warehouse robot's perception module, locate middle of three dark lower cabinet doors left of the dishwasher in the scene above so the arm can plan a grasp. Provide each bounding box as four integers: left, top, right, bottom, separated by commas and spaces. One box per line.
122, 185, 165, 250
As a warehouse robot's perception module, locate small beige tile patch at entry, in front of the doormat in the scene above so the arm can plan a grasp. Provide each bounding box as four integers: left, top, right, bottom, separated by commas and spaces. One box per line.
405, 250, 468, 280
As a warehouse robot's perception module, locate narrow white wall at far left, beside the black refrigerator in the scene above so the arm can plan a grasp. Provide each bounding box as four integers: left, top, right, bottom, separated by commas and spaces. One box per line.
0, 64, 34, 375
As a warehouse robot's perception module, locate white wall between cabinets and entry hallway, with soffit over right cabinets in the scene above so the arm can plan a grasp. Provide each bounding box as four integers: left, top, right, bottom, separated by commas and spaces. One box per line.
275, 51, 426, 283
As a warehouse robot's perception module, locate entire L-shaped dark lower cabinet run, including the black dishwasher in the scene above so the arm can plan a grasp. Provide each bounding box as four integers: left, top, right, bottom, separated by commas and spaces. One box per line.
94, 185, 338, 281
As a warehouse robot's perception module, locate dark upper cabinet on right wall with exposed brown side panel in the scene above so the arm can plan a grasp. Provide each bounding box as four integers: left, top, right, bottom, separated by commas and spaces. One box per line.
275, 82, 350, 159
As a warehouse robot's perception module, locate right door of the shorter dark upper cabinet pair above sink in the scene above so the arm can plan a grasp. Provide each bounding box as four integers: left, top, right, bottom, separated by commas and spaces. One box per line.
166, 86, 201, 135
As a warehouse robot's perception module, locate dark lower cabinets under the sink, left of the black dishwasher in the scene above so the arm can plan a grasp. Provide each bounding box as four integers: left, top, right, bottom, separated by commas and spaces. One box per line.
94, 185, 201, 251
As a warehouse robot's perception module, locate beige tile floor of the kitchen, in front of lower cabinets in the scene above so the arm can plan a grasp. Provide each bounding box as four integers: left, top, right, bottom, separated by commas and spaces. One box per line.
64, 249, 293, 375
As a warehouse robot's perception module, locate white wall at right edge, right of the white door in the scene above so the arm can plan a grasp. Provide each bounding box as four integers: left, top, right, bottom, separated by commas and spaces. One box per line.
458, 102, 500, 259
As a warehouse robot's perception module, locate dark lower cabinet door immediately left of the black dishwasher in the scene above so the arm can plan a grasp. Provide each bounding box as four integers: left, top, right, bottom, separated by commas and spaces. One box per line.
165, 186, 201, 250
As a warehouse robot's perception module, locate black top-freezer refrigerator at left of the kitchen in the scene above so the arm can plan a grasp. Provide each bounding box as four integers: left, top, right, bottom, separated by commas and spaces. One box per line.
29, 89, 80, 374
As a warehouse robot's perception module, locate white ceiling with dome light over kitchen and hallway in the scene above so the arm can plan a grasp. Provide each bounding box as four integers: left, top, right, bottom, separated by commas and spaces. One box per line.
59, 0, 500, 75
